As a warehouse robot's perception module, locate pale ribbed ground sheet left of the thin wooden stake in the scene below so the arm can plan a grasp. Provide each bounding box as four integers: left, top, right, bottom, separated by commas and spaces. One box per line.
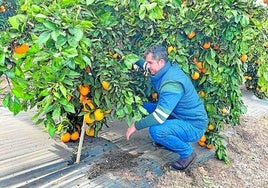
0, 107, 73, 187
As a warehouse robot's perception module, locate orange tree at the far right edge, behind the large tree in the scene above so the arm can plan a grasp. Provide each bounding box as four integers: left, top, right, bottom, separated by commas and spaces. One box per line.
244, 2, 268, 98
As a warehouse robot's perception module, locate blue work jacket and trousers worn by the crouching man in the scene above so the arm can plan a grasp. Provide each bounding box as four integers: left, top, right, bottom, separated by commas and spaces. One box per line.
135, 60, 208, 158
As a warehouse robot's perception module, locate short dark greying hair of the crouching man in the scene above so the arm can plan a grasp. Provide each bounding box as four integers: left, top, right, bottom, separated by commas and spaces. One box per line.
144, 45, 168, 62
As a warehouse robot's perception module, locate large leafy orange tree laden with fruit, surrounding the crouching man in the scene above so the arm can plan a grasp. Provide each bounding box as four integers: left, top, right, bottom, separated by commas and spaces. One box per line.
0, 0, 267, 163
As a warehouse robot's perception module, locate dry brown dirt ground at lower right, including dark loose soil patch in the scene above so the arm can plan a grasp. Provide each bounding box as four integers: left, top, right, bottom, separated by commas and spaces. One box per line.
0, 75, 268, 188
